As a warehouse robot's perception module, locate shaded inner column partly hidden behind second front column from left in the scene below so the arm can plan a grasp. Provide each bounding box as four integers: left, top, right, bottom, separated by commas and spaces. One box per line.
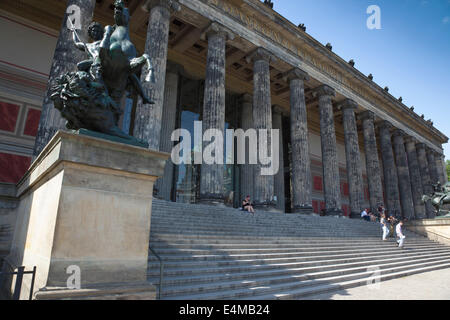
155, 62, 182, 201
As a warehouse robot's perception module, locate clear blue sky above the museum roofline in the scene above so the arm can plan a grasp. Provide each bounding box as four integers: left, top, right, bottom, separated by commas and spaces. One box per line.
273, 0, 450, 159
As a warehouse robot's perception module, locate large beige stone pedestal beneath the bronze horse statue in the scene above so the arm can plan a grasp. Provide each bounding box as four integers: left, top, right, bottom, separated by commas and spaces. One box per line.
1, 131, 169, 299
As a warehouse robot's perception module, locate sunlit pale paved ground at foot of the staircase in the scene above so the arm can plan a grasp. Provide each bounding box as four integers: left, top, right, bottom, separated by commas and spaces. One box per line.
310, 269, 450, 300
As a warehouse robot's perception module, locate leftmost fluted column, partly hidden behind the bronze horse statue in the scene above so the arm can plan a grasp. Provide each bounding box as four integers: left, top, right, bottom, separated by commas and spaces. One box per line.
33, 0, 96, 157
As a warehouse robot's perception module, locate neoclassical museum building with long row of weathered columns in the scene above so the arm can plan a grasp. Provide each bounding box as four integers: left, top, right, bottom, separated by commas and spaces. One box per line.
0, 0, 448, 219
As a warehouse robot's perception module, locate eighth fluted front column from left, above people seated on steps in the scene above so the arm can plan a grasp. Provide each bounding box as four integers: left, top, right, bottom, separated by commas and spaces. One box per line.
360, 111, 384, 212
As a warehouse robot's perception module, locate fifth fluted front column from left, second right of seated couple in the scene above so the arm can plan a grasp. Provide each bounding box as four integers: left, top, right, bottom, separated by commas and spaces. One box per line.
285, 68, 313, 213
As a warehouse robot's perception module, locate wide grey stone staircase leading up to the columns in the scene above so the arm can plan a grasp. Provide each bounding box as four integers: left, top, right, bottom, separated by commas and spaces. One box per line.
148, 200, 450, 300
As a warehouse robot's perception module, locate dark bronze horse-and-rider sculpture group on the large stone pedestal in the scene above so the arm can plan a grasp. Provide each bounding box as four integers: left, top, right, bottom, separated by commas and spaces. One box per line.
51, 0, 154, 144
